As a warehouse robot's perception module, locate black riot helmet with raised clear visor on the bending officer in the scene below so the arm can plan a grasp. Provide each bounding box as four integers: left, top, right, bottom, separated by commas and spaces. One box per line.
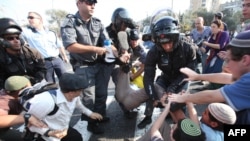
151, 16, 180, 44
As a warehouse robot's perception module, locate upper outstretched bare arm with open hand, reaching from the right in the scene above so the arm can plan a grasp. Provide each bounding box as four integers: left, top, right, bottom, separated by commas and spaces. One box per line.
180, 68, 233, 84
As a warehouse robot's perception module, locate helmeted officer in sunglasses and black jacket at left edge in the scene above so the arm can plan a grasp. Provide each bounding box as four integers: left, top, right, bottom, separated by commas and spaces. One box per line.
0, 18, 46, 88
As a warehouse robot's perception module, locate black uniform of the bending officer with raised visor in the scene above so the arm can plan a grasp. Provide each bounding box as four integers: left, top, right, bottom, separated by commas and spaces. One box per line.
144, 36, 196, 116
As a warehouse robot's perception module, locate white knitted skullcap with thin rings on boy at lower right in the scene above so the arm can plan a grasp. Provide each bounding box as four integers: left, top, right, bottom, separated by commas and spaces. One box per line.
208, 103, 236, 124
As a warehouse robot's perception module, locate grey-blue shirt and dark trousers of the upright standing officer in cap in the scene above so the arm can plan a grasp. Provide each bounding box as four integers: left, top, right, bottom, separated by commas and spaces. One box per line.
61, 12, 110, 115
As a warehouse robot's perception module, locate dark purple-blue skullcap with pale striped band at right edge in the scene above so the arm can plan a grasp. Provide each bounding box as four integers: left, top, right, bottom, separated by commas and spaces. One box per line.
228, 30, 250, 48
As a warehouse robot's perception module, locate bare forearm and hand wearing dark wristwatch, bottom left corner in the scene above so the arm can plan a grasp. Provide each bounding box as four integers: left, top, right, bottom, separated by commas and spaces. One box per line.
0, 115, 47, 128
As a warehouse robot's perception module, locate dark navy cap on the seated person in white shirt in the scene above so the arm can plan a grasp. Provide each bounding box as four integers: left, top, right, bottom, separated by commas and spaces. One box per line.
59, 73, 88, 91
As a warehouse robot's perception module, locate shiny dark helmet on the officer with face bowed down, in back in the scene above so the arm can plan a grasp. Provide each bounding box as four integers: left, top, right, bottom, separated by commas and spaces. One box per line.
111, 7, 137, 31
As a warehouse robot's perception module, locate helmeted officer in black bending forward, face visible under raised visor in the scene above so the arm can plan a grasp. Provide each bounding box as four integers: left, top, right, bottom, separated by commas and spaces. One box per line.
138, 16, 196, 128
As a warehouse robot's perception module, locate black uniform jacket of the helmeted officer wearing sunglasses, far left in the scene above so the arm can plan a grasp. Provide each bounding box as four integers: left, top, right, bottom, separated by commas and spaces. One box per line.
0, 45, 46, 88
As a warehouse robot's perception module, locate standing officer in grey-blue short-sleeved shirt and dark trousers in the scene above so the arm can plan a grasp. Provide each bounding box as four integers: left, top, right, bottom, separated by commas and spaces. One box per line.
61, 0, 110, 134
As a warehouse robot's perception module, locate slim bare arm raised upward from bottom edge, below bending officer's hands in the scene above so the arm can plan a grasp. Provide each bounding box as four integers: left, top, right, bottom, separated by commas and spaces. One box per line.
150, 101, 171, 137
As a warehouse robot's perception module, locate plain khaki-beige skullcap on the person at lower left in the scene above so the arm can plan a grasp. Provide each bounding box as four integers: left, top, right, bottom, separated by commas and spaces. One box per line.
4, 76, 30, 91
